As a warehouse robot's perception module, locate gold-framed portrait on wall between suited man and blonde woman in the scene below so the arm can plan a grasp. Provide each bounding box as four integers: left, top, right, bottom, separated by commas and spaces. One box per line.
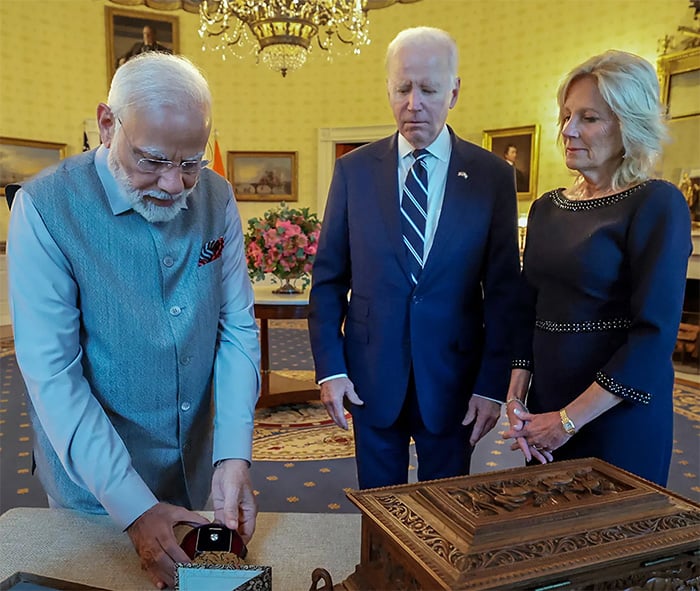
483, 125, 540, 200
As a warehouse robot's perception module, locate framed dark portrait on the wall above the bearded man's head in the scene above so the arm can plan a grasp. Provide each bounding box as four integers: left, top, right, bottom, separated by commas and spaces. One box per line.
105, 6, 180, 81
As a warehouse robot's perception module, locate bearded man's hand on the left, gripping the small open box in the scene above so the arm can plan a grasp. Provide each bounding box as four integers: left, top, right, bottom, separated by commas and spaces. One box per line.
126, 503, 209, 589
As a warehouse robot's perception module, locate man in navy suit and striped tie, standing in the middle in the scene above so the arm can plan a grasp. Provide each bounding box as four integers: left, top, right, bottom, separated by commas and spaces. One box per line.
309, 27, 518, 488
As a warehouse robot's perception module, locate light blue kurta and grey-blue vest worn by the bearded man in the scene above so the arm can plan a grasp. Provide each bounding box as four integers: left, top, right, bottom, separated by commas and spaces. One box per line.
8, 147, 259, 527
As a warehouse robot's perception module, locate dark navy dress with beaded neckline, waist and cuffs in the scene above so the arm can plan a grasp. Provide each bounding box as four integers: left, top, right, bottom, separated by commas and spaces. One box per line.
513, 180, 692, 485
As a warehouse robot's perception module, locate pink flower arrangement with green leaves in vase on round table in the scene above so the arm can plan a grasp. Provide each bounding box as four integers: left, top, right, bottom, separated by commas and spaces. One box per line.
245, 202, 321, 293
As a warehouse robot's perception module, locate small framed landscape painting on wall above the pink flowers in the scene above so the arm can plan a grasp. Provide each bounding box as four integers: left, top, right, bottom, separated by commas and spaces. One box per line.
226, 152, 299, 201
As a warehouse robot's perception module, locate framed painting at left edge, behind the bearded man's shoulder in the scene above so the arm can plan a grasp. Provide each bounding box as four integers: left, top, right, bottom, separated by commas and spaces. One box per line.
0, 137, 66, 195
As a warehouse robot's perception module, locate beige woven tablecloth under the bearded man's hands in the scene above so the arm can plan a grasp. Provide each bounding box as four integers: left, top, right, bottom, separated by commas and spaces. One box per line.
0, 508, 361, 591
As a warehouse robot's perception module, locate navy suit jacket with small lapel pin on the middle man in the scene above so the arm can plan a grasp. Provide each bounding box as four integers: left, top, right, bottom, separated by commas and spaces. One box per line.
309, 130, 519, 432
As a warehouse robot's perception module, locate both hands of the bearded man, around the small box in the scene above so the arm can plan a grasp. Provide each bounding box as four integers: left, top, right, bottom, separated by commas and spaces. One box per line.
126, 459, 257, 589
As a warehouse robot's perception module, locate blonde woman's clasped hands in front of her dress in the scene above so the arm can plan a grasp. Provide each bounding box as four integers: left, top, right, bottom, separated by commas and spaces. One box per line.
503, 399, 570, 464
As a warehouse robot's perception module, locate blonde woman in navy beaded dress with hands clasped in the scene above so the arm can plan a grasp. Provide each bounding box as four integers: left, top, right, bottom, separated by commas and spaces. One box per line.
505, 50, 691, 485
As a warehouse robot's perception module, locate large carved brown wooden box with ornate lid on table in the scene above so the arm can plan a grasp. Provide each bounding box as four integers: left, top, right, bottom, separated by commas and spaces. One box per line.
335, 458, 700, 591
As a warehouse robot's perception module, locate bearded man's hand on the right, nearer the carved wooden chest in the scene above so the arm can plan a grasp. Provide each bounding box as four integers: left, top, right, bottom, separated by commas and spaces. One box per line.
211, 459, 258, 544
